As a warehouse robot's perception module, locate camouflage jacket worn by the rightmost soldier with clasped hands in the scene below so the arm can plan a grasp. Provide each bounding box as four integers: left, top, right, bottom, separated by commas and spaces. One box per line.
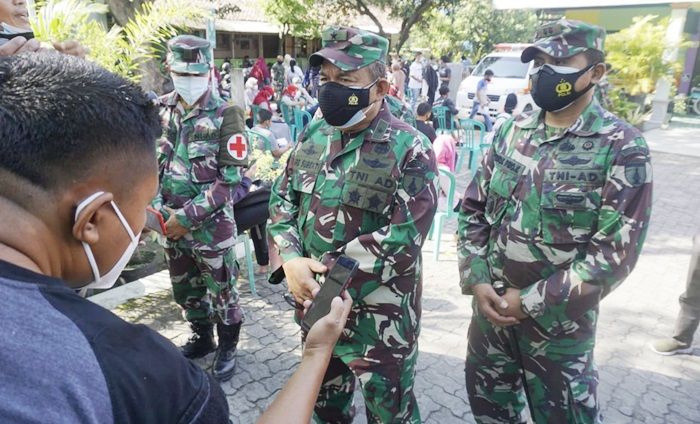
458, 100, 652, 335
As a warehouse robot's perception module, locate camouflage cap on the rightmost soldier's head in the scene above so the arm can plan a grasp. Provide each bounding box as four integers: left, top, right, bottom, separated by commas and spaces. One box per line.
520, 19, 605, 63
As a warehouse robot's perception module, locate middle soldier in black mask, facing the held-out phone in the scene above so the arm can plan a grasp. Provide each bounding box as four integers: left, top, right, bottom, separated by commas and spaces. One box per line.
269, 28, 437, 423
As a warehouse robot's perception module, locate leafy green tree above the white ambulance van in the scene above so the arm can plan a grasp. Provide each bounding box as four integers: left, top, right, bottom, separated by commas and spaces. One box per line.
409, 0, 538, 62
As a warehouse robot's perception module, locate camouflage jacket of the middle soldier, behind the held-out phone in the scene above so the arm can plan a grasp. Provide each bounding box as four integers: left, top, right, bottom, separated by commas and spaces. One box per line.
268, 103, 437, 352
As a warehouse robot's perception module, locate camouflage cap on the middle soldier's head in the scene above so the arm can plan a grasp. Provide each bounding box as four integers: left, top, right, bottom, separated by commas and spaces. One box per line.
309, 27, 389, 71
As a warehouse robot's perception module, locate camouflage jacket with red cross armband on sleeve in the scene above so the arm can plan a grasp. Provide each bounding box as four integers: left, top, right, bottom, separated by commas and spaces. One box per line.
153, 92, 248, 250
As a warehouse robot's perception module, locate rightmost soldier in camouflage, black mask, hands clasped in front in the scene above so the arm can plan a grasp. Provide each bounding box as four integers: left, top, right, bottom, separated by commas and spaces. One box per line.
458, 20, 652, 423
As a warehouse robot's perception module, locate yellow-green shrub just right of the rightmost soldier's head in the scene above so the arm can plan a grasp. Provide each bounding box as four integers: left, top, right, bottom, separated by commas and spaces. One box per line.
605, 15, 682, 95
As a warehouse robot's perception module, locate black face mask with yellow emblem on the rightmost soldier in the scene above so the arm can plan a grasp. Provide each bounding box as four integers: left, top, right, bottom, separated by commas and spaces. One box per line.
530, 64, 595, 112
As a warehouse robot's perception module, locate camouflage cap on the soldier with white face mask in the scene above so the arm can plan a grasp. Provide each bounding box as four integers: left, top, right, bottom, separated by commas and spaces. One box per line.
166, 35, 211, 74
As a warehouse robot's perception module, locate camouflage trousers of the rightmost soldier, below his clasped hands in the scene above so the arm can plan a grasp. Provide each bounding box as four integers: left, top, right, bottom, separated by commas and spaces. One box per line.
465, 308, 602, 424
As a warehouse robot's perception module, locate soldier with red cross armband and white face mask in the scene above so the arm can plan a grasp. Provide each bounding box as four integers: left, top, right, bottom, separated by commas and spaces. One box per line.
153, 36, 248, 380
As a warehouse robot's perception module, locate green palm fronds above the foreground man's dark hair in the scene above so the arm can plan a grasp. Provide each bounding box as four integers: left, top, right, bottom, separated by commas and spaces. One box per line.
32, 0, 207, 82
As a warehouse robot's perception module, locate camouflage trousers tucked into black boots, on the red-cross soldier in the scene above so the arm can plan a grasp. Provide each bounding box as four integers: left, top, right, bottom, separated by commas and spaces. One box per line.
165, 247, 243, 325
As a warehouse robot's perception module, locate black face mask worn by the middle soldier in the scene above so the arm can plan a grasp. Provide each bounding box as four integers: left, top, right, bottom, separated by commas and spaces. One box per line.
318, 80, 379, 129
